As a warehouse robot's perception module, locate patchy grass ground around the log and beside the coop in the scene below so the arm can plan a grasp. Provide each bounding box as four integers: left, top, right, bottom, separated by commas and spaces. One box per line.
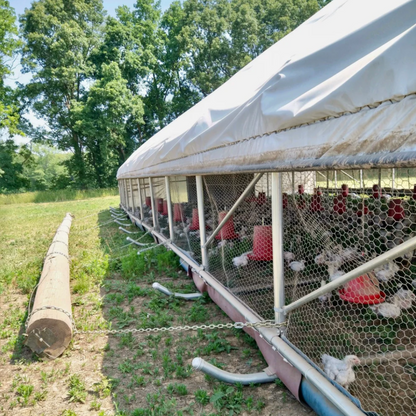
0, 196, 309, 416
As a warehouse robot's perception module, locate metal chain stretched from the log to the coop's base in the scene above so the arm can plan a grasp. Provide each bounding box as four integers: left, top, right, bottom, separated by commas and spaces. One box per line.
74, 321, 285, 335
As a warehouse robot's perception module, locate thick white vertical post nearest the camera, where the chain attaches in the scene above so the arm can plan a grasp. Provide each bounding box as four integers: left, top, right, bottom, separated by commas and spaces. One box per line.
272, 172, 285, 323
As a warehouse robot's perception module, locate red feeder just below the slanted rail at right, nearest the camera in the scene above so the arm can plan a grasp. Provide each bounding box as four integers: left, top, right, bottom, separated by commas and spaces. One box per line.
338, 274, 386, 305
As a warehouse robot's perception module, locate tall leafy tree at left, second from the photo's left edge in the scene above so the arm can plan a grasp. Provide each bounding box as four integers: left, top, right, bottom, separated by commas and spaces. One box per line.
20, 0, 105, 187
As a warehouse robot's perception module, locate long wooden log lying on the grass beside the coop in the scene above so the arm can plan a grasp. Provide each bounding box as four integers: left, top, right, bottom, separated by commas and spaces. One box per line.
26, 213, 73, 358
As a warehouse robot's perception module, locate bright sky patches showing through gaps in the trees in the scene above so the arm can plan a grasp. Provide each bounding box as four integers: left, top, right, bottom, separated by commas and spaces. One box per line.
6, 0, 173, 144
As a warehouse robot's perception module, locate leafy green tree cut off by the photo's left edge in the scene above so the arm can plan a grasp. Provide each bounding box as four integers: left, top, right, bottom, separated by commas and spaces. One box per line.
0, 0, 21, 134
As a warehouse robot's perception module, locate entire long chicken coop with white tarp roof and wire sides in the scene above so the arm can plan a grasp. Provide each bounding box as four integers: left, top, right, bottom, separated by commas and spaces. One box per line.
118, 0, 416, 415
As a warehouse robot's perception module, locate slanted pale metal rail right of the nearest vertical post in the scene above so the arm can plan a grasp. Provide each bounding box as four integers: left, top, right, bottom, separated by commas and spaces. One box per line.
283, 237, 416, 314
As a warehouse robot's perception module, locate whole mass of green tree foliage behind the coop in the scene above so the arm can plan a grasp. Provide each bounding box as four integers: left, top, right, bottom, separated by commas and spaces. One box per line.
0, 0, 327, 193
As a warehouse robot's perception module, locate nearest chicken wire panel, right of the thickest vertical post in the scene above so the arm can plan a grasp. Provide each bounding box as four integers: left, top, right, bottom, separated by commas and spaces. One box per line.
284, 169, 416, 415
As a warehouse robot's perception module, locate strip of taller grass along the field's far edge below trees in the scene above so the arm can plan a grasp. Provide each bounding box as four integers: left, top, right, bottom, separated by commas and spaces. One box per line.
0, 188, 118, 205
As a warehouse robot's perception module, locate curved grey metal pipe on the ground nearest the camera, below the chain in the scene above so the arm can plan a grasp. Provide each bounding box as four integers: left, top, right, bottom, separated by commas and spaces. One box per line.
192, 357, 277, 384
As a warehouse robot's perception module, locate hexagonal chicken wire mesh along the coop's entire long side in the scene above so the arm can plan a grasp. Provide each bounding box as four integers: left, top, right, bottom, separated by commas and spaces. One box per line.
122, 169, 416, 415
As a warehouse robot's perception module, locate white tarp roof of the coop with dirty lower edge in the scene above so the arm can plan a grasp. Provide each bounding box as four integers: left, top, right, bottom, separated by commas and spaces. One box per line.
117, 0, 416, 179
